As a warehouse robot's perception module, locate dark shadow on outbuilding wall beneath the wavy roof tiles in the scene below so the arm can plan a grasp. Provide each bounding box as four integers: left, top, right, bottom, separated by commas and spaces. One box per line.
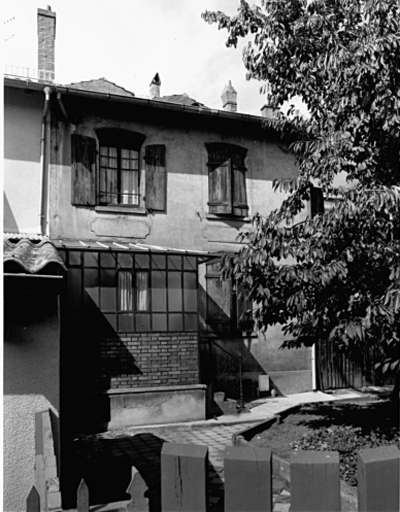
4, 272, 60, 411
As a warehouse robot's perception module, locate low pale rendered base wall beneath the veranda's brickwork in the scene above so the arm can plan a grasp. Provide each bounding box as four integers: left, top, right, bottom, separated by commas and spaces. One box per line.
106, 384, 206, 430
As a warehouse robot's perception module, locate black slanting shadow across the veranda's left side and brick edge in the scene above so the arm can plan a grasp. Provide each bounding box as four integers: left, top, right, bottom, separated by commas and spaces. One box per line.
61, 291, 142, 434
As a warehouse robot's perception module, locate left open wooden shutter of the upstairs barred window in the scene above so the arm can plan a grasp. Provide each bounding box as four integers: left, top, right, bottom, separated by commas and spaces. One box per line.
71, 134, 96, 206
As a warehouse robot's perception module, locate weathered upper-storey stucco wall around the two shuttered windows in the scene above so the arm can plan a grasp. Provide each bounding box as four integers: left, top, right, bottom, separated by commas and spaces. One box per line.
51, 109, 304, 250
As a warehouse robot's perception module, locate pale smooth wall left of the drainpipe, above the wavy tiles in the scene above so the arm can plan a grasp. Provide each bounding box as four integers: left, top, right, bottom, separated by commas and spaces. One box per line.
4, 87, 49, 233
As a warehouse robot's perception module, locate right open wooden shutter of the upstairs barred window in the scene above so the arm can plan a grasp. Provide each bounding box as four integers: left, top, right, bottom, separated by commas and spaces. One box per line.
145, 144, 167, 211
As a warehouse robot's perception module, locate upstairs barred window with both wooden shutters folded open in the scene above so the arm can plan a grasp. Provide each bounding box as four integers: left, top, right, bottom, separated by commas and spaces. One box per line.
71, 128, 166, 211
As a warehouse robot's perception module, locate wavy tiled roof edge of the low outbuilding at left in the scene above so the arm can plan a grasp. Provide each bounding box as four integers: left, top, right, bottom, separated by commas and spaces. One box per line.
3, 239, 67, 274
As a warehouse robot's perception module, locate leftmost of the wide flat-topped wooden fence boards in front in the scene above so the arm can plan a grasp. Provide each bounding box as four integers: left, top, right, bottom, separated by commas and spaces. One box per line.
161, 443, 208, 512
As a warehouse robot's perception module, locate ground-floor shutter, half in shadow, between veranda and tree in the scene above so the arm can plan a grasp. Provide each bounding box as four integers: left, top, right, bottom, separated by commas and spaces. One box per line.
205, 261, 232, 333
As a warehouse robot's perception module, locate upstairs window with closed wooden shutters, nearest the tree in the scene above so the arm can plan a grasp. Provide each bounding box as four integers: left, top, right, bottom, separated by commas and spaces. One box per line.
206, 143, 249, 217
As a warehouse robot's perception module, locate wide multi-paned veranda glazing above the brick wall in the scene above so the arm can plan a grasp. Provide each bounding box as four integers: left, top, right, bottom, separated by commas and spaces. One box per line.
67, 250, 198, 336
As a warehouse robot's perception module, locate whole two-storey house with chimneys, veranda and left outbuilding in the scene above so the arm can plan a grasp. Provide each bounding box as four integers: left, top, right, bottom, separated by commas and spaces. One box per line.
4, 10, 312, 510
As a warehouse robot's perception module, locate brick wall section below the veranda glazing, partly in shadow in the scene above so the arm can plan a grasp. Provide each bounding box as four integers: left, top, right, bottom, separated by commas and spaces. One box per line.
95, 332, 199, 389
